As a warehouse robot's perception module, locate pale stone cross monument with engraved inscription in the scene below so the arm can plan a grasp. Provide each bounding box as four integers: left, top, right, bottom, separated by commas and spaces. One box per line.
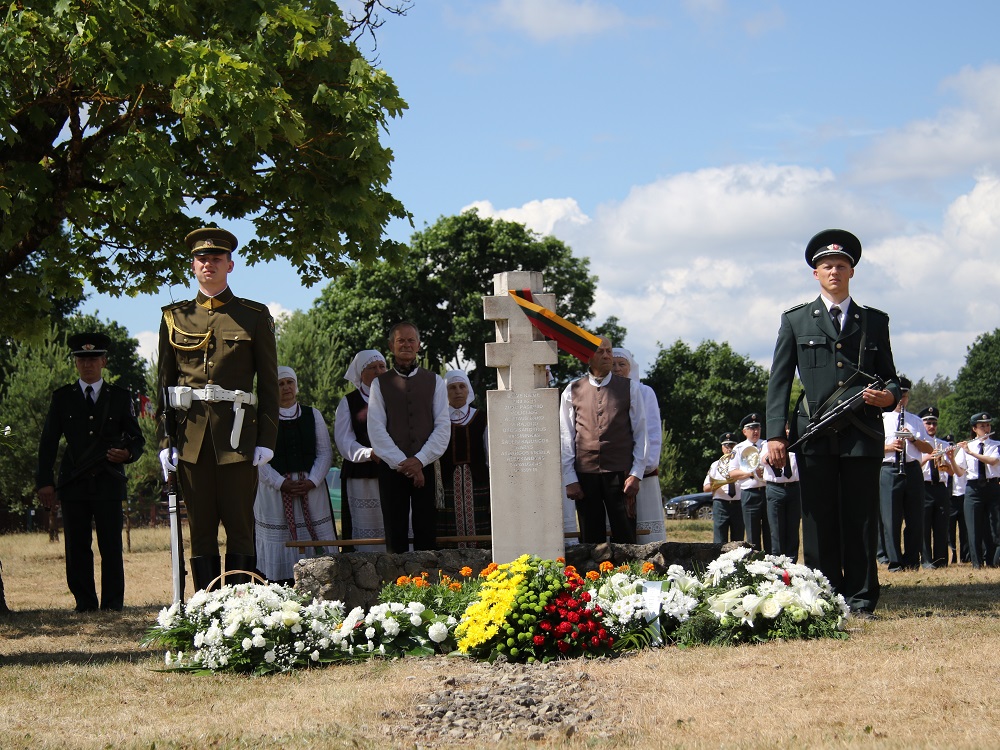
483, 271, 565, 563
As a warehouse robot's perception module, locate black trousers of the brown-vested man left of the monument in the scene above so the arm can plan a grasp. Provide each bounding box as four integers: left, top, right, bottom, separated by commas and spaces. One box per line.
378, 461, 437, 552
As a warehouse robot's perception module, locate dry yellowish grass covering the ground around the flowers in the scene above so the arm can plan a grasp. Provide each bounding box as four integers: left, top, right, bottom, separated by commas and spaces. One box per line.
0, 522, 1000, 750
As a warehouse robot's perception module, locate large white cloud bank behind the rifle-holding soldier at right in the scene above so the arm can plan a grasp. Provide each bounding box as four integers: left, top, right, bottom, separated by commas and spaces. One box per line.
475, 169, 1000, 379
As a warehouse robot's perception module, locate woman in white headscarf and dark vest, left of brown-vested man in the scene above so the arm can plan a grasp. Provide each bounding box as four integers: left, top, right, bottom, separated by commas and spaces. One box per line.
333, 349, 386, 552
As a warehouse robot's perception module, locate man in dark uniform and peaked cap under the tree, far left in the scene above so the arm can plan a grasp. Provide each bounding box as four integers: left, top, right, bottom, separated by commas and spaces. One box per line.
35, 333, 146, 612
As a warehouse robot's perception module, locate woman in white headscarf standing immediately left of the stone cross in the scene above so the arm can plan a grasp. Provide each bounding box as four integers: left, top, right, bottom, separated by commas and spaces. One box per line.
437, 370, 492, 549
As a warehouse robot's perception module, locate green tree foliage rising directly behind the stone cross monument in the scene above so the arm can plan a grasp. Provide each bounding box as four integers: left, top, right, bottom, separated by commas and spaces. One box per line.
278, 211, 597, 419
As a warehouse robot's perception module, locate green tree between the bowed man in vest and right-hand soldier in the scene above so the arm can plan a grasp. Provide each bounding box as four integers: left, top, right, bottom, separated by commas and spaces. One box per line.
643, 339, 768, 495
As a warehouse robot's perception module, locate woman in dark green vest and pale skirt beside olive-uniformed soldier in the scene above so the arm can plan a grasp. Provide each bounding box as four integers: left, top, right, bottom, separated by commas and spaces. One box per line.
254, 367, 337, 582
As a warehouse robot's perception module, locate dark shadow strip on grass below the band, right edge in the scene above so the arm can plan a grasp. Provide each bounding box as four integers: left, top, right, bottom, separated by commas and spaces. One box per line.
879, 583, 1000, 618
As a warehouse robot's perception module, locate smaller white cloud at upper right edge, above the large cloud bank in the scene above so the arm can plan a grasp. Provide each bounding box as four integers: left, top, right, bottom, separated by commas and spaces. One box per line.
853, 65, 1000, 182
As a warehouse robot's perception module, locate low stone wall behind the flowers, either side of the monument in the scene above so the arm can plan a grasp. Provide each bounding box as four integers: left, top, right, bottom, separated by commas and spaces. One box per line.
295, 542, 744, 611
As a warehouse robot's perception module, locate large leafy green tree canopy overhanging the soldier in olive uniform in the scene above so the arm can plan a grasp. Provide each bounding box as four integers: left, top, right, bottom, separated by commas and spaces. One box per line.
0, 0, 408, 333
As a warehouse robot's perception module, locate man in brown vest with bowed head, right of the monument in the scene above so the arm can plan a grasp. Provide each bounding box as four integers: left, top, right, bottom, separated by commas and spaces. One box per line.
559, 337, 646, 544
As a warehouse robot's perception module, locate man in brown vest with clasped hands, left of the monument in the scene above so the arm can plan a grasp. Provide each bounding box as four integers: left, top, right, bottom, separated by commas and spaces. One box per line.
368, 321, 451, 552
